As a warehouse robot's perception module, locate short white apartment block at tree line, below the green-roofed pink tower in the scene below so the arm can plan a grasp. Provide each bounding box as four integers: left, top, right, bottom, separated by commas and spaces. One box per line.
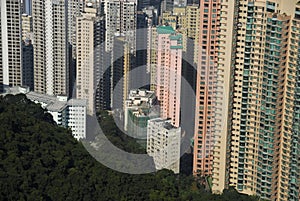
147, 118, 181, 174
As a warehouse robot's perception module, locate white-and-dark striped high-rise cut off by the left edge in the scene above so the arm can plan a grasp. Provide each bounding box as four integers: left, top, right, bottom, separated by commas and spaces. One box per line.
0, 0, 22, 90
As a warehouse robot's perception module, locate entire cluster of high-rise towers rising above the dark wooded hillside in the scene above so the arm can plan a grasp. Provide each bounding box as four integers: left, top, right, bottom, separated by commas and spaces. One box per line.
0, 0, 300, 201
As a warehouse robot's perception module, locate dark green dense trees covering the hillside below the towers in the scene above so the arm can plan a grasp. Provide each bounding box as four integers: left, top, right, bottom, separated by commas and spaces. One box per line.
0, 95, 256, 201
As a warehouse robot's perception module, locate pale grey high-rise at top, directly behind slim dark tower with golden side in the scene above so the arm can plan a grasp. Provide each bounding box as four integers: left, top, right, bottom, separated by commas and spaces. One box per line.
104, 0, 137, 53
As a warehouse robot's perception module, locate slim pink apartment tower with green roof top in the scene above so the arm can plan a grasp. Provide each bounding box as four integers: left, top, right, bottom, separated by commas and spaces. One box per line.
156, 26, 183, 127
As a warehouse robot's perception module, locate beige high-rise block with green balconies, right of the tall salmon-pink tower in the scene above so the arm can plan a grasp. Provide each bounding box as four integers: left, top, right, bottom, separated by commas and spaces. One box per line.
213, 0, 300, 201
